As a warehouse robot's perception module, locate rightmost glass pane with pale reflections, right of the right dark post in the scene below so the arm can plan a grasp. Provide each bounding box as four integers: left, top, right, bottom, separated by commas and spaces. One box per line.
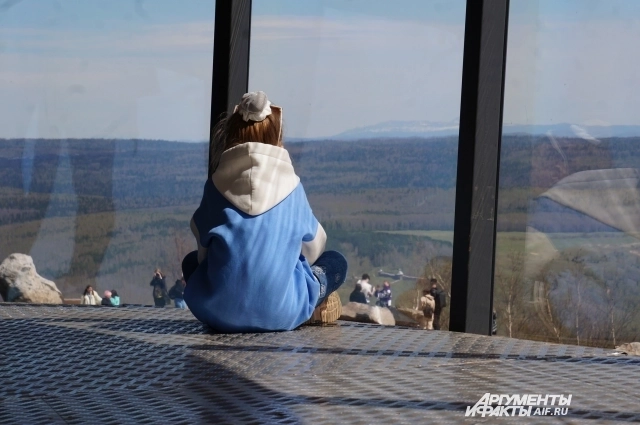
494, 0, 640, 347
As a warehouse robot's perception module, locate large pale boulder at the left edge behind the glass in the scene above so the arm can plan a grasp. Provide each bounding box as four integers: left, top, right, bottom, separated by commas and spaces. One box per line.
0, 254, 63, 304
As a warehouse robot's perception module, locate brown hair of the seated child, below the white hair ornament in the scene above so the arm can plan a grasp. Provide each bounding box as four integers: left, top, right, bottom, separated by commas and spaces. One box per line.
209, 105, 282, 177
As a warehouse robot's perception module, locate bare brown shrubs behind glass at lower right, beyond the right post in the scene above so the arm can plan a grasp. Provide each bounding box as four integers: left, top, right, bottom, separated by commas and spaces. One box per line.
494, 245, 640, 348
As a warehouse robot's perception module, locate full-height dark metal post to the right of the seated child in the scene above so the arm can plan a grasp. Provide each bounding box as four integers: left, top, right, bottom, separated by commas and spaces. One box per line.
449, 0, 509, 335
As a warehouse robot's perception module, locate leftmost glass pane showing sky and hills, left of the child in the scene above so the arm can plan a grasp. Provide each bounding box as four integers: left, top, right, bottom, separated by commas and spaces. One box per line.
0, 0, 214, 304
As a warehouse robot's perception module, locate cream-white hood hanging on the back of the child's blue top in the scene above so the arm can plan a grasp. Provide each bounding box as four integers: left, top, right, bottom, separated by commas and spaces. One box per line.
212, 142, 300, 215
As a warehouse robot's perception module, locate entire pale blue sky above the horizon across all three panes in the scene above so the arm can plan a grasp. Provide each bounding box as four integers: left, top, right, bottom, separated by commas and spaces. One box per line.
0, 0, 640, 141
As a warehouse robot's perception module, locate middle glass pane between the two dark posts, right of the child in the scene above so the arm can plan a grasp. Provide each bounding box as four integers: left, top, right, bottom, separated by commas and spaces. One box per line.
249, 0, 465, 329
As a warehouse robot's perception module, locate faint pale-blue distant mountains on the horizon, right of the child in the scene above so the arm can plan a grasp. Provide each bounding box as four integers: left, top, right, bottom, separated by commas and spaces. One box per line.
328, 121, 640, 140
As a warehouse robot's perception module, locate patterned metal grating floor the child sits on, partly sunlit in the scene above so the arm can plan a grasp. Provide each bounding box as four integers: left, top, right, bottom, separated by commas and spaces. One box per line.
0, 304, 640, 424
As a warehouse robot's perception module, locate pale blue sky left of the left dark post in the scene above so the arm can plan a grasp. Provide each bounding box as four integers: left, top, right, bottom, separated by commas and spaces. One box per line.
0, 0, 215, 141
